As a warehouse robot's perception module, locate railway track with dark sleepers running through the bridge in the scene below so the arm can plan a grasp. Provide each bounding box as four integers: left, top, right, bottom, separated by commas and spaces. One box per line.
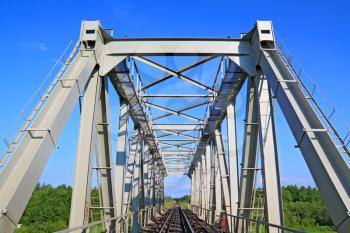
142, 206, 217, 233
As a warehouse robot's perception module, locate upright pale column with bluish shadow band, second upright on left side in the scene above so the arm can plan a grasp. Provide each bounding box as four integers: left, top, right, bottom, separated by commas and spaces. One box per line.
114, 100, 129, 233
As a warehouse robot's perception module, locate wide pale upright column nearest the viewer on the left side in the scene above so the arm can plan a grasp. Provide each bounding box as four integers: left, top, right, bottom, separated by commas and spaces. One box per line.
69, 71, 101, 232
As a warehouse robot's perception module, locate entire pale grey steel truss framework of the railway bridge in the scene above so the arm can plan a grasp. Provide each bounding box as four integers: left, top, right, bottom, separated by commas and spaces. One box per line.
0, 21, 350, 233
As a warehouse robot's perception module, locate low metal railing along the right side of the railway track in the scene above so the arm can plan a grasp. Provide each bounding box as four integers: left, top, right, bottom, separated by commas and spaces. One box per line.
190, 204, 307, 233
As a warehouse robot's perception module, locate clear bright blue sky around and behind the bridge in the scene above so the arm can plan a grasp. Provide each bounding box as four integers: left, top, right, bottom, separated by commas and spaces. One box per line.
0, 0, 350, 196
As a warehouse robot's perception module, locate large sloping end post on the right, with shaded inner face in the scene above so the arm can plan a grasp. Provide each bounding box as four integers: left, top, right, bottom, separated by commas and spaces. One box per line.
259, 50, 350, 233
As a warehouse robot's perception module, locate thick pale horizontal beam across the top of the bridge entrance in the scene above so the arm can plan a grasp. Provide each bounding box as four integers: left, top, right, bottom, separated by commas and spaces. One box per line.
104, 38, 251, 56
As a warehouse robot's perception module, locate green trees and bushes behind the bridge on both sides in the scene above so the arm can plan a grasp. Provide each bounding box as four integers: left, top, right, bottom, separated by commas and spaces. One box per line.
16, 184, 334, 233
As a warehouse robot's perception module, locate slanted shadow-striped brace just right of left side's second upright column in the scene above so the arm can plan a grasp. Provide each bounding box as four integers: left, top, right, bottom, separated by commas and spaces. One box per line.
122, 129, 141, 233
